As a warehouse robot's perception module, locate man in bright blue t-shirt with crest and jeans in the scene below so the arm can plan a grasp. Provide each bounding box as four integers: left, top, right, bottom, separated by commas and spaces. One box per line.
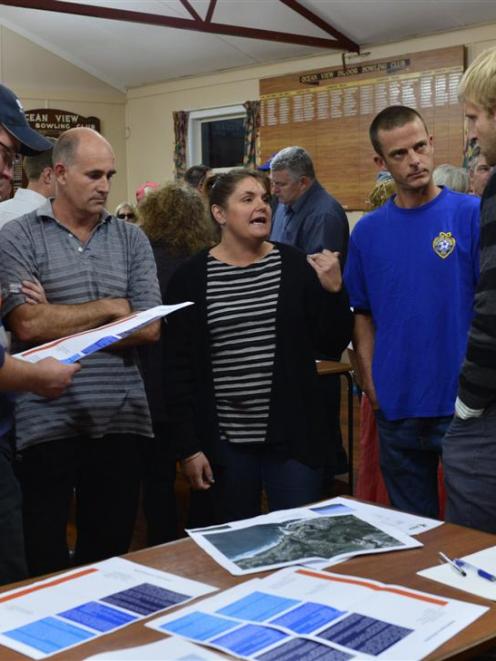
345, 106, 479, 517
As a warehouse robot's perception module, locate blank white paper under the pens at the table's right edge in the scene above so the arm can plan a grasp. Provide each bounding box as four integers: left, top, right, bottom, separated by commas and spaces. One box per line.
417, 546, 496, 601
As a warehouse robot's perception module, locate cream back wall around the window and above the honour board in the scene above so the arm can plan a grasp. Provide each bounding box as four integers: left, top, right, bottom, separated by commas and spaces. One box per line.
126, 24, 496, 223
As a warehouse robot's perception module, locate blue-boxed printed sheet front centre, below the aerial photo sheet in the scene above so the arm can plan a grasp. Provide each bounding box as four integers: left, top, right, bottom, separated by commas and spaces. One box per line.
146, 568, 488, 661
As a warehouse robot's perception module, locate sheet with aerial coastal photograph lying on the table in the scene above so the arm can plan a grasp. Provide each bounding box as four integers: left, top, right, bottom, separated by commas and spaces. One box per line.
187, 504, 422, 575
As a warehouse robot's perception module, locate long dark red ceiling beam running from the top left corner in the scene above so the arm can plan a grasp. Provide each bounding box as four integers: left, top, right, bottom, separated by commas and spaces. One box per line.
0, 0, 358, 50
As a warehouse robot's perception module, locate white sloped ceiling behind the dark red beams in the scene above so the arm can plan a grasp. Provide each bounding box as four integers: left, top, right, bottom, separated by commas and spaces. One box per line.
0, 0, 496, 90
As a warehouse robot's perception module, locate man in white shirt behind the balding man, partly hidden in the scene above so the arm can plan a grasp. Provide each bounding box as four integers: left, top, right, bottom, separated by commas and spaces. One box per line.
0, 138, 57, 229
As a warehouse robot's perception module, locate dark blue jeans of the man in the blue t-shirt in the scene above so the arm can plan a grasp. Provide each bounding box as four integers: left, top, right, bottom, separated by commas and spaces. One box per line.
376, 411, 451, 518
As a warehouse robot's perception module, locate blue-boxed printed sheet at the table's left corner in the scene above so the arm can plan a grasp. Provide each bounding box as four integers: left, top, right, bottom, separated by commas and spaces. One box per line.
0, 558, 217, 659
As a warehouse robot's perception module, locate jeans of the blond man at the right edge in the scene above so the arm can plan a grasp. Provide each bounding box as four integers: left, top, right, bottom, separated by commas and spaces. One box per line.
443, 406, 496, 533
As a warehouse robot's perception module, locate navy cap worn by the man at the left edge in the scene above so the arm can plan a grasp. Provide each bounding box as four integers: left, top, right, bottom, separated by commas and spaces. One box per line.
0, 85, 53, 156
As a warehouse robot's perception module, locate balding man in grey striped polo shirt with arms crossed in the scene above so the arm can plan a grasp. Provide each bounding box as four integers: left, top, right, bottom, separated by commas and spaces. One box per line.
0, 128, 161, 575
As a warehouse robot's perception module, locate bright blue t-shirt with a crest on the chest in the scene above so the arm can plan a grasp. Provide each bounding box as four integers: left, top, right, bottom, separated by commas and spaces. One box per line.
345, 188, 479, 420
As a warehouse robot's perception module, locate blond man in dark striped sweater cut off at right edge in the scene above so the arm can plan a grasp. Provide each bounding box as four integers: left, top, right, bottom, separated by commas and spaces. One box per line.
443, 48, 496, 533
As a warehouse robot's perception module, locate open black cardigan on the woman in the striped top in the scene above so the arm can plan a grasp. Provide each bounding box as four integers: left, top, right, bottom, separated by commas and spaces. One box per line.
164, 244, 353, 467
